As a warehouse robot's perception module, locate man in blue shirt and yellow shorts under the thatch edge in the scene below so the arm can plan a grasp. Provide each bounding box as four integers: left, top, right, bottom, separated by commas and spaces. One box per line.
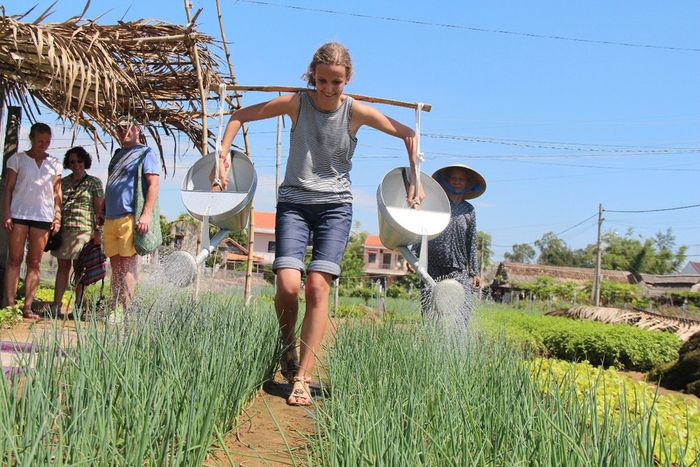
103, 116, 160, 310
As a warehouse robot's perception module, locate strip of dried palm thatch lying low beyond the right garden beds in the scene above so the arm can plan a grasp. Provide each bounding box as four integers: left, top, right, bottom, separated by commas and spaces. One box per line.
547, 306, 700, 341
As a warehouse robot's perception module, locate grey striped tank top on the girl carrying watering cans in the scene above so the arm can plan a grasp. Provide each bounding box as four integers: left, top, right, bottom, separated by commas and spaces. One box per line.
278, 92, 357, 204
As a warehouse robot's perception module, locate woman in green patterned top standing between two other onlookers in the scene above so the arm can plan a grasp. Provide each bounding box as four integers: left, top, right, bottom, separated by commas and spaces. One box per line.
51, 146, 104, 317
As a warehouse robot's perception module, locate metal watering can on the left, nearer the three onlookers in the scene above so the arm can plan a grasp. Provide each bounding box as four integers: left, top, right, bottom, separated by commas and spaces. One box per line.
166, 150, 258, 287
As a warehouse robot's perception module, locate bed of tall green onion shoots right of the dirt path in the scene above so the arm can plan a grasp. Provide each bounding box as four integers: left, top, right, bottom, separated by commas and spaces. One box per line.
311, 324, 696, 466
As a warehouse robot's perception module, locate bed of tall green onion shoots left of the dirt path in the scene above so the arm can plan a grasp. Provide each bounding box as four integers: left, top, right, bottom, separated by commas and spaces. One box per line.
0, 292, 278, 465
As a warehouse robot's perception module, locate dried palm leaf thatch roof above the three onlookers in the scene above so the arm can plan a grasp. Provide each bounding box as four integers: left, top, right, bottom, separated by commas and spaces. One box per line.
0, 10, 230, 167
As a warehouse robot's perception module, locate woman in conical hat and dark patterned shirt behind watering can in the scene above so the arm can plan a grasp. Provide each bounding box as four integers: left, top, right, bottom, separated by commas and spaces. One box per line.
418, 164, 486, 318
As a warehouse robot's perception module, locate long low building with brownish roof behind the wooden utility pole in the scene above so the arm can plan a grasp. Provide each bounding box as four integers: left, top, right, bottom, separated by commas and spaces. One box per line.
490, 262, 637, 302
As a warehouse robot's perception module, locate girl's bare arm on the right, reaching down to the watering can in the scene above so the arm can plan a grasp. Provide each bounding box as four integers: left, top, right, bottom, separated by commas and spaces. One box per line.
350, 101, 425, 206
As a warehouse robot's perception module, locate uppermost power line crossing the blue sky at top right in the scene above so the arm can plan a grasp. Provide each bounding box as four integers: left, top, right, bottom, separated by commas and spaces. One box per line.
240, 0, 700, 52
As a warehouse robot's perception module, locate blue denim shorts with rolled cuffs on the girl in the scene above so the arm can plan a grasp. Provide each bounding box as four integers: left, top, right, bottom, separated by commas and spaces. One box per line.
272, 203, 352, 277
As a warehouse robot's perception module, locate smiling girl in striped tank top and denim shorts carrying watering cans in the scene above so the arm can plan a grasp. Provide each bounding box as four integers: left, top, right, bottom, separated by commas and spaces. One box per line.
212, 42, 416, 405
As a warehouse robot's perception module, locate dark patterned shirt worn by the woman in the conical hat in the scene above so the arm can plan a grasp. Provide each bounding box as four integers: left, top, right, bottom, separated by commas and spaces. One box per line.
418, 201, 479, 278
